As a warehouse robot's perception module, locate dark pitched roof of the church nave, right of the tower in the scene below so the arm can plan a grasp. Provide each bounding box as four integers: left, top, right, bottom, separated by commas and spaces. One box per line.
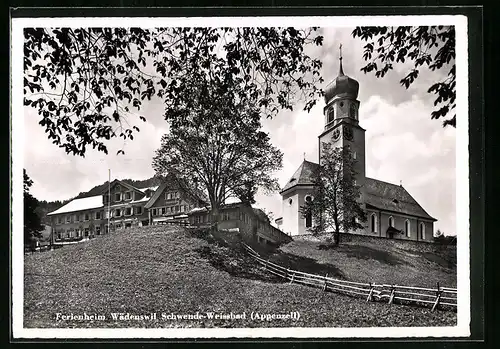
364, 177, 437, 221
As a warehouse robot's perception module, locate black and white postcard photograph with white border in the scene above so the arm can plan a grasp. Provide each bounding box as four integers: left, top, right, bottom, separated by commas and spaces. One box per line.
11, 15, 470, 338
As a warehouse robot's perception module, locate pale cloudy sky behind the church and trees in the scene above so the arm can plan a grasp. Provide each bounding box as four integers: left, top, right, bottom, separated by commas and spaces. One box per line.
24, 28, 456, 235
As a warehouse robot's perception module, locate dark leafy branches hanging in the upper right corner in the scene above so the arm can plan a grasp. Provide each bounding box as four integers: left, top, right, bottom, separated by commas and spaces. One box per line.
352, 25, 456, 127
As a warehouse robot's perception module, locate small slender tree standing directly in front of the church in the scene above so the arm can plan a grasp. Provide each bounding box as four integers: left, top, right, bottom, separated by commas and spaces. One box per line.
301, 143, 367, 245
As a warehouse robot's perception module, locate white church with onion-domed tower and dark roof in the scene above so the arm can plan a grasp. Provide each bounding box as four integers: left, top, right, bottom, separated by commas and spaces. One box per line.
276, 46, 436, 242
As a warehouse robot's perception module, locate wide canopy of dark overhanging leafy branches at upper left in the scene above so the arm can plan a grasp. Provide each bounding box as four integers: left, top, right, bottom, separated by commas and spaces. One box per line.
24, 27, 323, 156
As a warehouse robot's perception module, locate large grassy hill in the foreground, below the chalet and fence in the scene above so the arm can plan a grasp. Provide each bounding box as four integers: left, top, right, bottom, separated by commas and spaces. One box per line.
24, 227, 456, 328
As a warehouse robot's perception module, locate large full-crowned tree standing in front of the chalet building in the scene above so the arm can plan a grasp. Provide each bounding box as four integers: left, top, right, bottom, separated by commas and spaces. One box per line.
153, 73, 282, 226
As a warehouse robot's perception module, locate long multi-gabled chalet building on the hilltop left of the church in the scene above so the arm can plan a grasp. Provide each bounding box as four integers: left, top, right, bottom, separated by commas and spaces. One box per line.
48, 180, 290, 244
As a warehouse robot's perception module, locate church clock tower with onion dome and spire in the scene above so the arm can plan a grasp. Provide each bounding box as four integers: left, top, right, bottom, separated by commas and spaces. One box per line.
318, 45, 365, 186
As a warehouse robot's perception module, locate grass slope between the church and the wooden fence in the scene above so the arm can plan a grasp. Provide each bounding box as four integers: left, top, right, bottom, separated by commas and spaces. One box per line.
270, 237, 457, 287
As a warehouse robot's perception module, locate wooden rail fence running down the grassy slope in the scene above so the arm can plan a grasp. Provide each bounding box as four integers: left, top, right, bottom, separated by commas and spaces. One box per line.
244, 244, 457, 311
